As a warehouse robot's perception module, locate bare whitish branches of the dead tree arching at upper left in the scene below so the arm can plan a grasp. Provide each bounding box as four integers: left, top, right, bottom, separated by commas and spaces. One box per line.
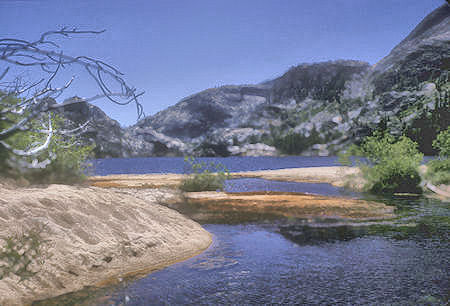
0, 28, 143, 168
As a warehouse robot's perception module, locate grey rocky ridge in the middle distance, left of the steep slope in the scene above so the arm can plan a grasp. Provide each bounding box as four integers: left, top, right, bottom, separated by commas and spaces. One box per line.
128, 60, 369, 156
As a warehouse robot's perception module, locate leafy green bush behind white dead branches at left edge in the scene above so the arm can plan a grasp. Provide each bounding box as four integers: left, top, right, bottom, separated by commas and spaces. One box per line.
0, 97, 93, 183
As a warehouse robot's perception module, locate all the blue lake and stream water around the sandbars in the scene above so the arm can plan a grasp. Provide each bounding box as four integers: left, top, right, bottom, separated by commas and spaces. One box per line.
37, 157, 450, 305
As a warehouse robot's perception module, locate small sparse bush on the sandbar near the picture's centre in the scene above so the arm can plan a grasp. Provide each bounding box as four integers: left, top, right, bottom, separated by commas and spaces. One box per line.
180, 157, 229, 192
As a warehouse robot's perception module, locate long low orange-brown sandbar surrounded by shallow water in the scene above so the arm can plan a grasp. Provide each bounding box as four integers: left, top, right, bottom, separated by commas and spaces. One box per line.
183, 191, 394, 222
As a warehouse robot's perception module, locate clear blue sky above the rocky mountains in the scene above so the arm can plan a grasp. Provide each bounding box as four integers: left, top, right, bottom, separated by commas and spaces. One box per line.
0, 0, 445, 126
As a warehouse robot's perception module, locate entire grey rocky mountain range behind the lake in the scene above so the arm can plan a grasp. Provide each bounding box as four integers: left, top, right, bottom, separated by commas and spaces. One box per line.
67, 4, 450, 156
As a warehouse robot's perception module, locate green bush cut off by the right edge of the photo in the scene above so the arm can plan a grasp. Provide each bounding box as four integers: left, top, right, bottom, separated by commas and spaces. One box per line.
426, 127, 450, 185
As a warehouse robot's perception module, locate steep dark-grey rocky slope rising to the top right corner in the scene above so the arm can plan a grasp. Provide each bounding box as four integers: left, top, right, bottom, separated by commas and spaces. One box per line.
343, 4, 450, 154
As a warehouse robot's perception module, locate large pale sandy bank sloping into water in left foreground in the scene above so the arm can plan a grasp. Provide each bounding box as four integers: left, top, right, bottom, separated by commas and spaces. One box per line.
0, 183, 212, 305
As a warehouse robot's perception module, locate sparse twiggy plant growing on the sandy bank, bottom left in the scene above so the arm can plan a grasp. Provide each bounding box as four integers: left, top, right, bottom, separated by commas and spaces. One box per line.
0, 228, 48, 281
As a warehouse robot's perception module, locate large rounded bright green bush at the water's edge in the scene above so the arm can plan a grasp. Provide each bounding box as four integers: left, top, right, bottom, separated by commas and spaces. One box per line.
360, 132, 423, 194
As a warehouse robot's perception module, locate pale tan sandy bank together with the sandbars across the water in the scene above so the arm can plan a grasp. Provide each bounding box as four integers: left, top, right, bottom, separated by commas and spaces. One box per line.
0, 167, 442, 305
